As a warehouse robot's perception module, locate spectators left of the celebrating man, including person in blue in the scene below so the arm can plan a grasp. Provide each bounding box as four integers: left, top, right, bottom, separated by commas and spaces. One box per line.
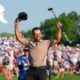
0, 37, 29, 80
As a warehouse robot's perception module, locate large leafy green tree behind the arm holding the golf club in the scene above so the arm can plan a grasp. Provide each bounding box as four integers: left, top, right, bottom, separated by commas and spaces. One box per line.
40, 11, 80, 44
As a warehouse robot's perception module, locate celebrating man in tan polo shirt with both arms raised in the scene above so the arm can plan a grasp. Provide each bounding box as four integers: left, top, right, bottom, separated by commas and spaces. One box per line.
14, 12, 62, 80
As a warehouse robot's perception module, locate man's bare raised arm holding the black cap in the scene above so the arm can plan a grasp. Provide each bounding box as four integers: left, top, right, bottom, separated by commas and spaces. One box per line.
14, 19, 27, 45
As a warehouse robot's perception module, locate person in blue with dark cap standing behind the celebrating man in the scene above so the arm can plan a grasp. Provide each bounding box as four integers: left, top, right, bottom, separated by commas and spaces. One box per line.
18, 47, 29, 80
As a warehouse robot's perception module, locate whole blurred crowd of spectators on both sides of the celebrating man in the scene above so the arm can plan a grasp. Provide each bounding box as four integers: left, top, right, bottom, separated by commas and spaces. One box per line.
0, 38, 80, 78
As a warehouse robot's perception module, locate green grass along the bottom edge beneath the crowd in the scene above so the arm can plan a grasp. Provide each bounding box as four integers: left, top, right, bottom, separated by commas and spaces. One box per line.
0, 74, 80, 80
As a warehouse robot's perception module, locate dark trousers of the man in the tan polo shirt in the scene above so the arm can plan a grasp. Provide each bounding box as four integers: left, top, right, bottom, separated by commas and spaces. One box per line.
25, 66, 47, 80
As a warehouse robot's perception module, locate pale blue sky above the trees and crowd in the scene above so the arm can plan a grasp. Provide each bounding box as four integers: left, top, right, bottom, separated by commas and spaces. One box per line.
0, 0, 80, 33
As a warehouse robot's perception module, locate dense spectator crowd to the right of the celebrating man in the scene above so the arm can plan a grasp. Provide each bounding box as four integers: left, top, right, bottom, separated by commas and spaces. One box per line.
48, 44, 80, 77
